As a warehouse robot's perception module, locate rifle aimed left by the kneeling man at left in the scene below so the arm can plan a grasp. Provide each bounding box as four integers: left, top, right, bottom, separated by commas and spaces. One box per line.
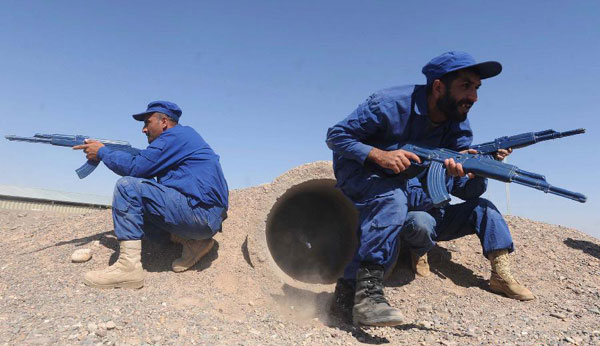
4, 133, 140, 179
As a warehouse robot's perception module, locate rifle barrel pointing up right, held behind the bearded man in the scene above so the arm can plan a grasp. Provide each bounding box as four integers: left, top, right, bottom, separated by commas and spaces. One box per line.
471, 129, 585, 154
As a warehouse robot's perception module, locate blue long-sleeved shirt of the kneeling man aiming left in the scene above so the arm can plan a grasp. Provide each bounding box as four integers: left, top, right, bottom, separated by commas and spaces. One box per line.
98, 125, 228, 209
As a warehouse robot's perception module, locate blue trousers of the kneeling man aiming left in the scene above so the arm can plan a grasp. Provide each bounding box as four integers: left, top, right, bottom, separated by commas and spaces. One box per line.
112, 177, 224, 240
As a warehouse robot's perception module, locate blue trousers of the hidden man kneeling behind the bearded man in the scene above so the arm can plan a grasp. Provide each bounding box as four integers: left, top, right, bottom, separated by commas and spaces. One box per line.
400, 198, 514, 257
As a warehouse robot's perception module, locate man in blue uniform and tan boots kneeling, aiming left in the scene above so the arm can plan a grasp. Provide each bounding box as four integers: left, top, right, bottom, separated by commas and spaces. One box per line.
74, 101, 228, 288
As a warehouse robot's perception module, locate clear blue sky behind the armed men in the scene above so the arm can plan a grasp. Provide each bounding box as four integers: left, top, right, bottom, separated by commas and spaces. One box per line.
0, 1, 600, 237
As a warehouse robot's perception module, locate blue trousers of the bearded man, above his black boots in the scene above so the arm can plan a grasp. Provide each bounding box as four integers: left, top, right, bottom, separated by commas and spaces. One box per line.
344, 179, 408, 280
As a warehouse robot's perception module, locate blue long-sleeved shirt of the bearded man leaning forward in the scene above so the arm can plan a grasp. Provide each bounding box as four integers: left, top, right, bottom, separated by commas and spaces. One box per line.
326, 85, 482, 200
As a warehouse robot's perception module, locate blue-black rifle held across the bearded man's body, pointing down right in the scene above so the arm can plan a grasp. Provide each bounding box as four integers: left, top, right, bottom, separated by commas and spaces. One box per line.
400, 144, 587, 207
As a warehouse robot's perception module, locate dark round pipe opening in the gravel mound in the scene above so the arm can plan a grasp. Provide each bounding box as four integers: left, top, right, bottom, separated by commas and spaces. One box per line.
266, 179, 358, 284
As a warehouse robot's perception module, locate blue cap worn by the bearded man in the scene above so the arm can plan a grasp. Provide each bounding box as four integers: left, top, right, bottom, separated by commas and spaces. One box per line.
421, 51, 502, 84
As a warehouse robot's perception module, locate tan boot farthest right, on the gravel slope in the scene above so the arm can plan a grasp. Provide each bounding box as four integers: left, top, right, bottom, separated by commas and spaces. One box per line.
488, 250, 535, 300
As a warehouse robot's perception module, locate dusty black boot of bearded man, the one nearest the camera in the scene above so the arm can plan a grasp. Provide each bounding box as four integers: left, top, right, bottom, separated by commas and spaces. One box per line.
352, 264, 404, 326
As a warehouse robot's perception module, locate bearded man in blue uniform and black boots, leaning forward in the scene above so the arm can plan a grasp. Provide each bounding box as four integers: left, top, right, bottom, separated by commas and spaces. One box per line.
326, 52, 532, 326
